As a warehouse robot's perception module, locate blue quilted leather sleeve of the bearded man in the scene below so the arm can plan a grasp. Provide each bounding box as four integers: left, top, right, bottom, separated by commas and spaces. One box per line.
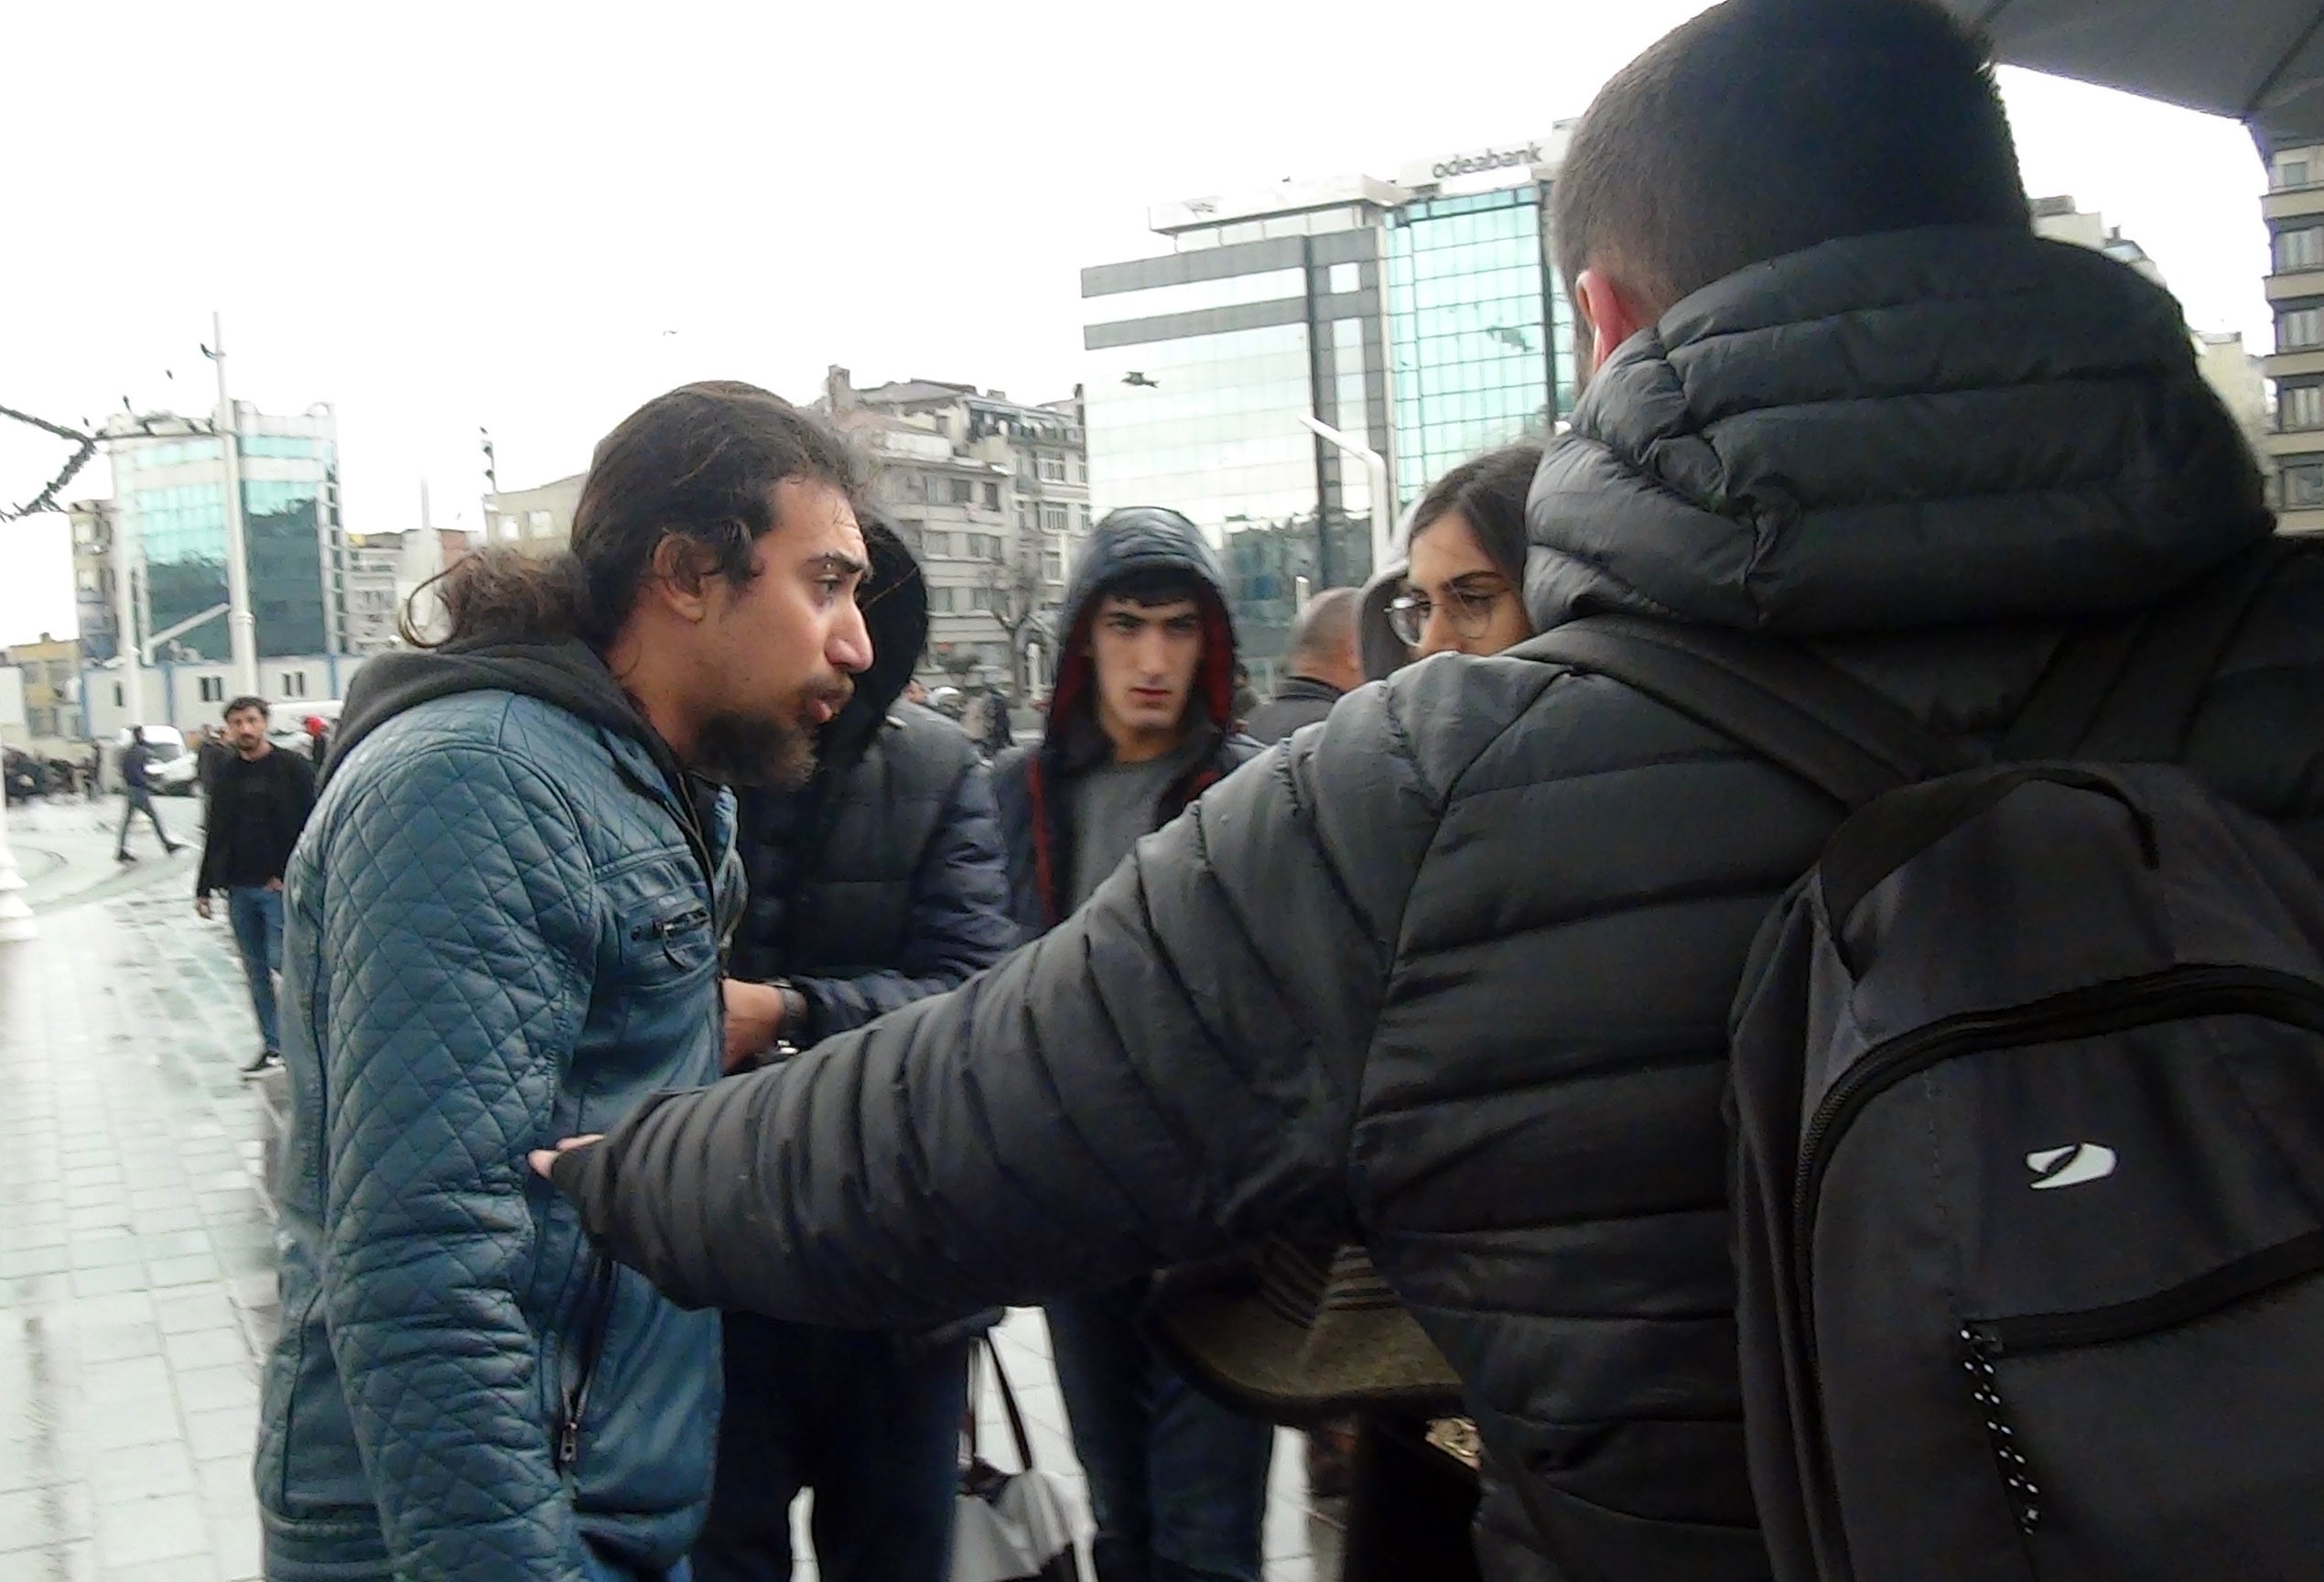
320, 743, 598, 1582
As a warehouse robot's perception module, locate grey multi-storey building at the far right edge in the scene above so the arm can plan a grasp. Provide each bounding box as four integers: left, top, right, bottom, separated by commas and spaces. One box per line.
2259, 144, 2324, 532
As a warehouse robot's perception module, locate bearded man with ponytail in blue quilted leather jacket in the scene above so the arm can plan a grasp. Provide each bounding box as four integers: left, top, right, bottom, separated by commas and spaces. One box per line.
258, 384, 871, 1582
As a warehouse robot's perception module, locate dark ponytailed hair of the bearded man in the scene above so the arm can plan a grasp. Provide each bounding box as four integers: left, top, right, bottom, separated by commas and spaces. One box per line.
402, 379, 862, 648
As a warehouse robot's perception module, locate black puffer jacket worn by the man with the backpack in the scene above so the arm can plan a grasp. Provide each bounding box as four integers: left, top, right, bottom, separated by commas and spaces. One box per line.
557, 230, 2324, 1582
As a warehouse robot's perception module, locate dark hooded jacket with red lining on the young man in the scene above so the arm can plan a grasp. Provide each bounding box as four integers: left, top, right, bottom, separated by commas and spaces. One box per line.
992, 506, 1259, 938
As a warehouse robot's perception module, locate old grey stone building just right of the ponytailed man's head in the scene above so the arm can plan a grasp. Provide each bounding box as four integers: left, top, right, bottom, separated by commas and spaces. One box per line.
816, 367, 1090, 692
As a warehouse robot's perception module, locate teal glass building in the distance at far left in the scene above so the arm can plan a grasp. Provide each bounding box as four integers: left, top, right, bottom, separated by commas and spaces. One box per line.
98, 406, 344, 660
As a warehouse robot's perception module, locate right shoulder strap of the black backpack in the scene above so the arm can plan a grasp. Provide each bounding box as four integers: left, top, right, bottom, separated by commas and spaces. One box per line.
1996, 536, 2303, 762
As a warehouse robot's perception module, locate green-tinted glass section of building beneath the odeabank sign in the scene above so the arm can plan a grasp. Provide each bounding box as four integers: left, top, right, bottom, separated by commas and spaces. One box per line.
1388, 183, 1573, 506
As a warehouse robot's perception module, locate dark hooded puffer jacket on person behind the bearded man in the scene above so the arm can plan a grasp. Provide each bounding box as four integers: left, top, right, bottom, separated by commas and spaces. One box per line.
728, 525, 1016, 1047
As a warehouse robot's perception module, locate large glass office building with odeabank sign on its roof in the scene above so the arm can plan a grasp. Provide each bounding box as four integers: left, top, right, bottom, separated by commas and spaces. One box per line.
1081, 125, 1573, 680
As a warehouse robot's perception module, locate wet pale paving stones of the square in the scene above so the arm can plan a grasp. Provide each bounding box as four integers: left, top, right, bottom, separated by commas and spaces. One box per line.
0, 887, 1338, 1582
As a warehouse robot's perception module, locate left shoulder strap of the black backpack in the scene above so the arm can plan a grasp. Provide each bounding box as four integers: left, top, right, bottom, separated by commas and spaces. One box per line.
1508, 615, 1962, 808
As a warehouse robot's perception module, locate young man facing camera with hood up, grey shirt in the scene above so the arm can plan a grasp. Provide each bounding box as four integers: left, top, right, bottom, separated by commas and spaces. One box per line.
992, 506, 1273, 1582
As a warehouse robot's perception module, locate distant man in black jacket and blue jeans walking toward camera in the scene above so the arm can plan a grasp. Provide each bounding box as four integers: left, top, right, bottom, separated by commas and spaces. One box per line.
193, 697, 314, 1076
